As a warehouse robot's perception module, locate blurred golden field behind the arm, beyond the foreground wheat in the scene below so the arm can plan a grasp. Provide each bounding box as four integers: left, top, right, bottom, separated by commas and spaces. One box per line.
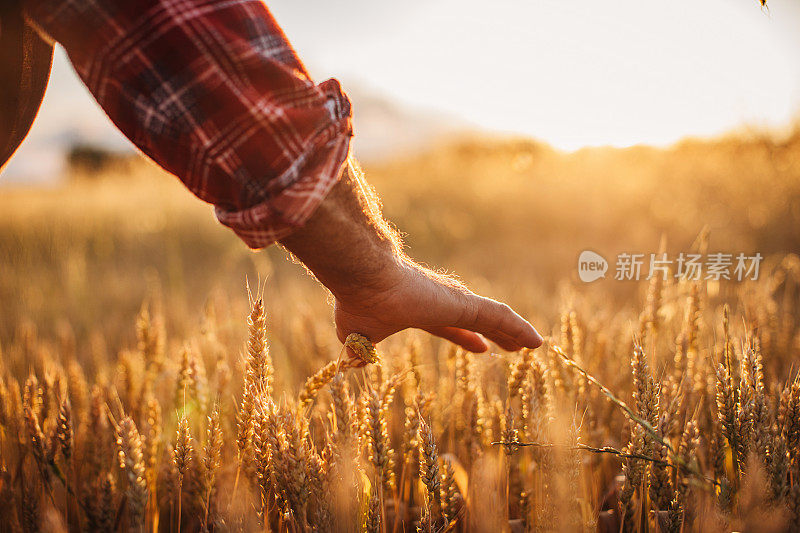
0, 131, 800, 362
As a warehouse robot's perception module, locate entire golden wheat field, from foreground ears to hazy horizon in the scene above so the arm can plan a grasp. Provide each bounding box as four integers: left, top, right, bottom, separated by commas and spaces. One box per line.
0, 133, 800, 532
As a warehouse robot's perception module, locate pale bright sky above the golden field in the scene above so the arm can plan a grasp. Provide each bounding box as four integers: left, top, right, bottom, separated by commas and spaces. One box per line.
0, 0, 800, 180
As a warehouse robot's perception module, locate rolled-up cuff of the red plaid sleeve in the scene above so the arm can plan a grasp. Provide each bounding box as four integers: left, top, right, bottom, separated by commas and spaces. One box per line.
214, 80, 353, 249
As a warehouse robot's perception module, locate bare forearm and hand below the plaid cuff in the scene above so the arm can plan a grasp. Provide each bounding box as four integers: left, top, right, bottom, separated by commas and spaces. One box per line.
281, 156, 542, 352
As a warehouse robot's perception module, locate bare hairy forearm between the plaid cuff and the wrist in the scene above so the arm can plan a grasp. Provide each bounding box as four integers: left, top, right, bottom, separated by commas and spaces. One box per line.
281, 158, 406, 297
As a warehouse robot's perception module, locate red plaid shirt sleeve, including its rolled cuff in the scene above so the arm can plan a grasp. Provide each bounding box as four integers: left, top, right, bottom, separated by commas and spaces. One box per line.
25, 0, 352, 248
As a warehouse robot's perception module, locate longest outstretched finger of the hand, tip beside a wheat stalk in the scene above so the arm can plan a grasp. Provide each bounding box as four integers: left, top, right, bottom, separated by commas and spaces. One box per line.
456, 293, 542, 351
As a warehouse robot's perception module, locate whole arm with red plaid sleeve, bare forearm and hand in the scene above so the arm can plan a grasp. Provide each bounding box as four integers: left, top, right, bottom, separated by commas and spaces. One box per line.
23, 0, 541, 351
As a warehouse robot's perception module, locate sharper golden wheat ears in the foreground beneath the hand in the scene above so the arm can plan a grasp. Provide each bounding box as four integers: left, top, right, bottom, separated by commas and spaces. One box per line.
0, 270, 800, 532
